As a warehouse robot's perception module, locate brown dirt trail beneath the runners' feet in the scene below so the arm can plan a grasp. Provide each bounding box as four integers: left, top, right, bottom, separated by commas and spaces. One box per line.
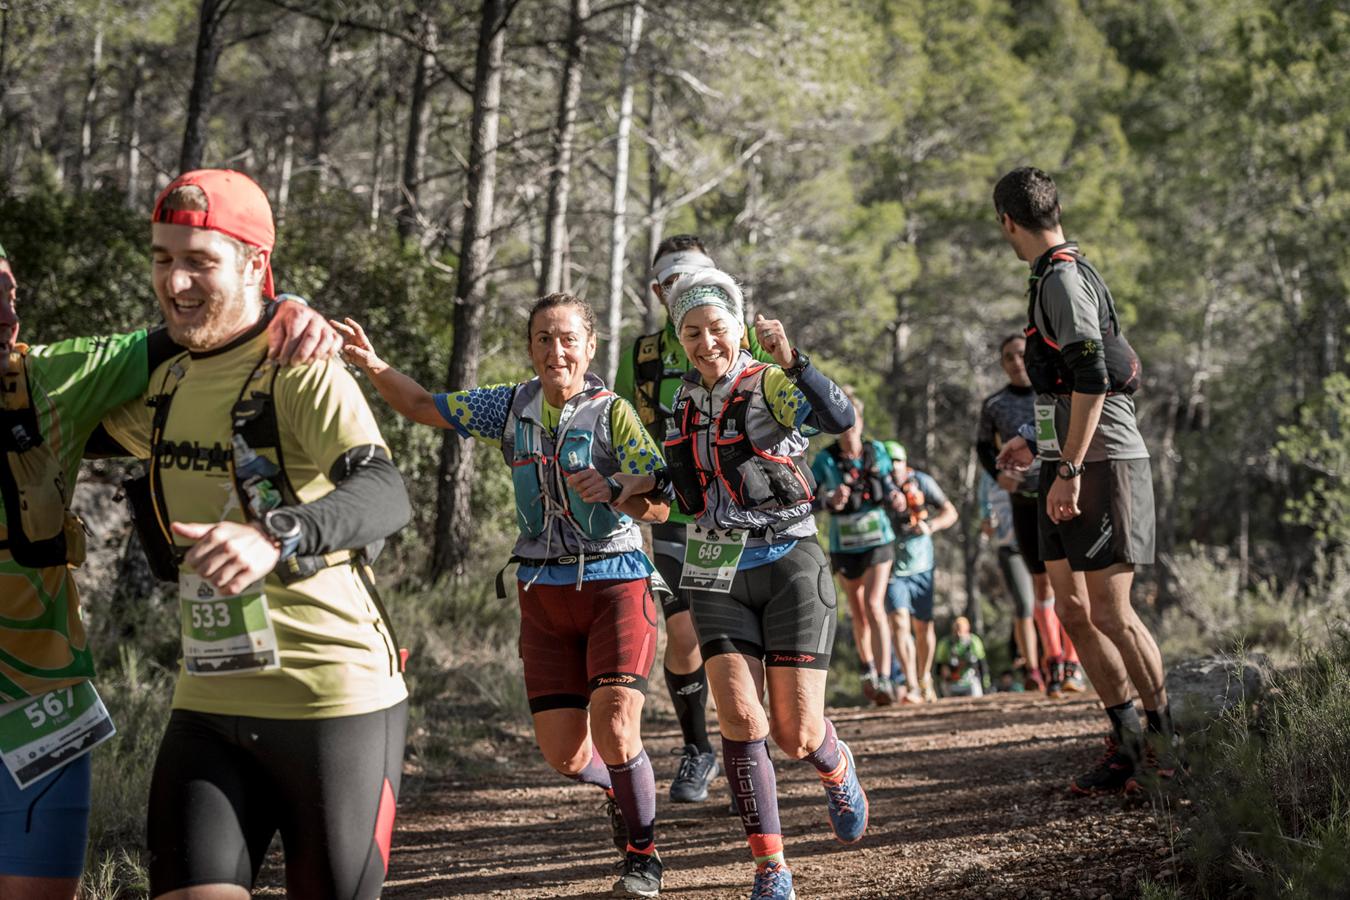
372, 694, 1172, 900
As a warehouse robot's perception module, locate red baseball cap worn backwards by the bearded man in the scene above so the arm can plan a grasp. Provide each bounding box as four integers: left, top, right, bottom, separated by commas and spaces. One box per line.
150, 169, 277, 300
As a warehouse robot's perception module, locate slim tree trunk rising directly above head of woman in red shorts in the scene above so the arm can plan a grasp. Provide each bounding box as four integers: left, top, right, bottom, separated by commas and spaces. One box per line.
539, 0, 590, 296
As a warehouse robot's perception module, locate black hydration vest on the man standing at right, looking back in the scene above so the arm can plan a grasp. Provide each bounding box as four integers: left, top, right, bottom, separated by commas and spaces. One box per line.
1023, 242, 1141, 394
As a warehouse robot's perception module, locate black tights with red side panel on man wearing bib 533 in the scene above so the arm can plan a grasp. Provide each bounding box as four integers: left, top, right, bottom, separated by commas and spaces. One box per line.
146, 700, 408, 900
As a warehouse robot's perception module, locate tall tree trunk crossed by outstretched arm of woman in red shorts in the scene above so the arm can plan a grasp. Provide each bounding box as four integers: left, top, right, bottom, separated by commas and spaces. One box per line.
429, 0, 506, 580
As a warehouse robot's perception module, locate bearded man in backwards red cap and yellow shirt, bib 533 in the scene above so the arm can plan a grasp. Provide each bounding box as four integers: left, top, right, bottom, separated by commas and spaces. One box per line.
104, 170, 412, 899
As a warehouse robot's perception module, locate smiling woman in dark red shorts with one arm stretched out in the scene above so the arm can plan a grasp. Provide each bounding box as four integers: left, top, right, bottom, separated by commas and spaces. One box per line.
333, 293, 670, 897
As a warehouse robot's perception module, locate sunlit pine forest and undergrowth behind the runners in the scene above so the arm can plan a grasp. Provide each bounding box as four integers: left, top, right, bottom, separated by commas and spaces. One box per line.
0, 0, 1350, 892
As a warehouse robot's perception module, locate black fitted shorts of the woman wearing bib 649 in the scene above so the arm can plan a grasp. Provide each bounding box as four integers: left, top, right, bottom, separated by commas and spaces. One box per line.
690, 537, 837, 669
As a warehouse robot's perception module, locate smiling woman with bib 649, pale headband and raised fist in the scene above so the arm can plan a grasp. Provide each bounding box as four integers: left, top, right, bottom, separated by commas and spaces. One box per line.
666, 270, 867, 900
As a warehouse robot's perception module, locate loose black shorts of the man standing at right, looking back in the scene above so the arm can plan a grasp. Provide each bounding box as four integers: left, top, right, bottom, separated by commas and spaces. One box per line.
1037, 459, 1154, 572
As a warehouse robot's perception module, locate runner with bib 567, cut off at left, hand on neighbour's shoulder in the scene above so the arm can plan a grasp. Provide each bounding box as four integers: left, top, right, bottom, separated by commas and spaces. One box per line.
0, 214, 332, 900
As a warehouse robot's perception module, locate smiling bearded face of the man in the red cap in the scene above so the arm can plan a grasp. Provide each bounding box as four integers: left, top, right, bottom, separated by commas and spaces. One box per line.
150, 223, 267, 352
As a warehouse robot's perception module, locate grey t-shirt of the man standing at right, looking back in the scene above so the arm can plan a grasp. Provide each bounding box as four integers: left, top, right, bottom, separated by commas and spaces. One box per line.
1033, 260, 1149, 463
